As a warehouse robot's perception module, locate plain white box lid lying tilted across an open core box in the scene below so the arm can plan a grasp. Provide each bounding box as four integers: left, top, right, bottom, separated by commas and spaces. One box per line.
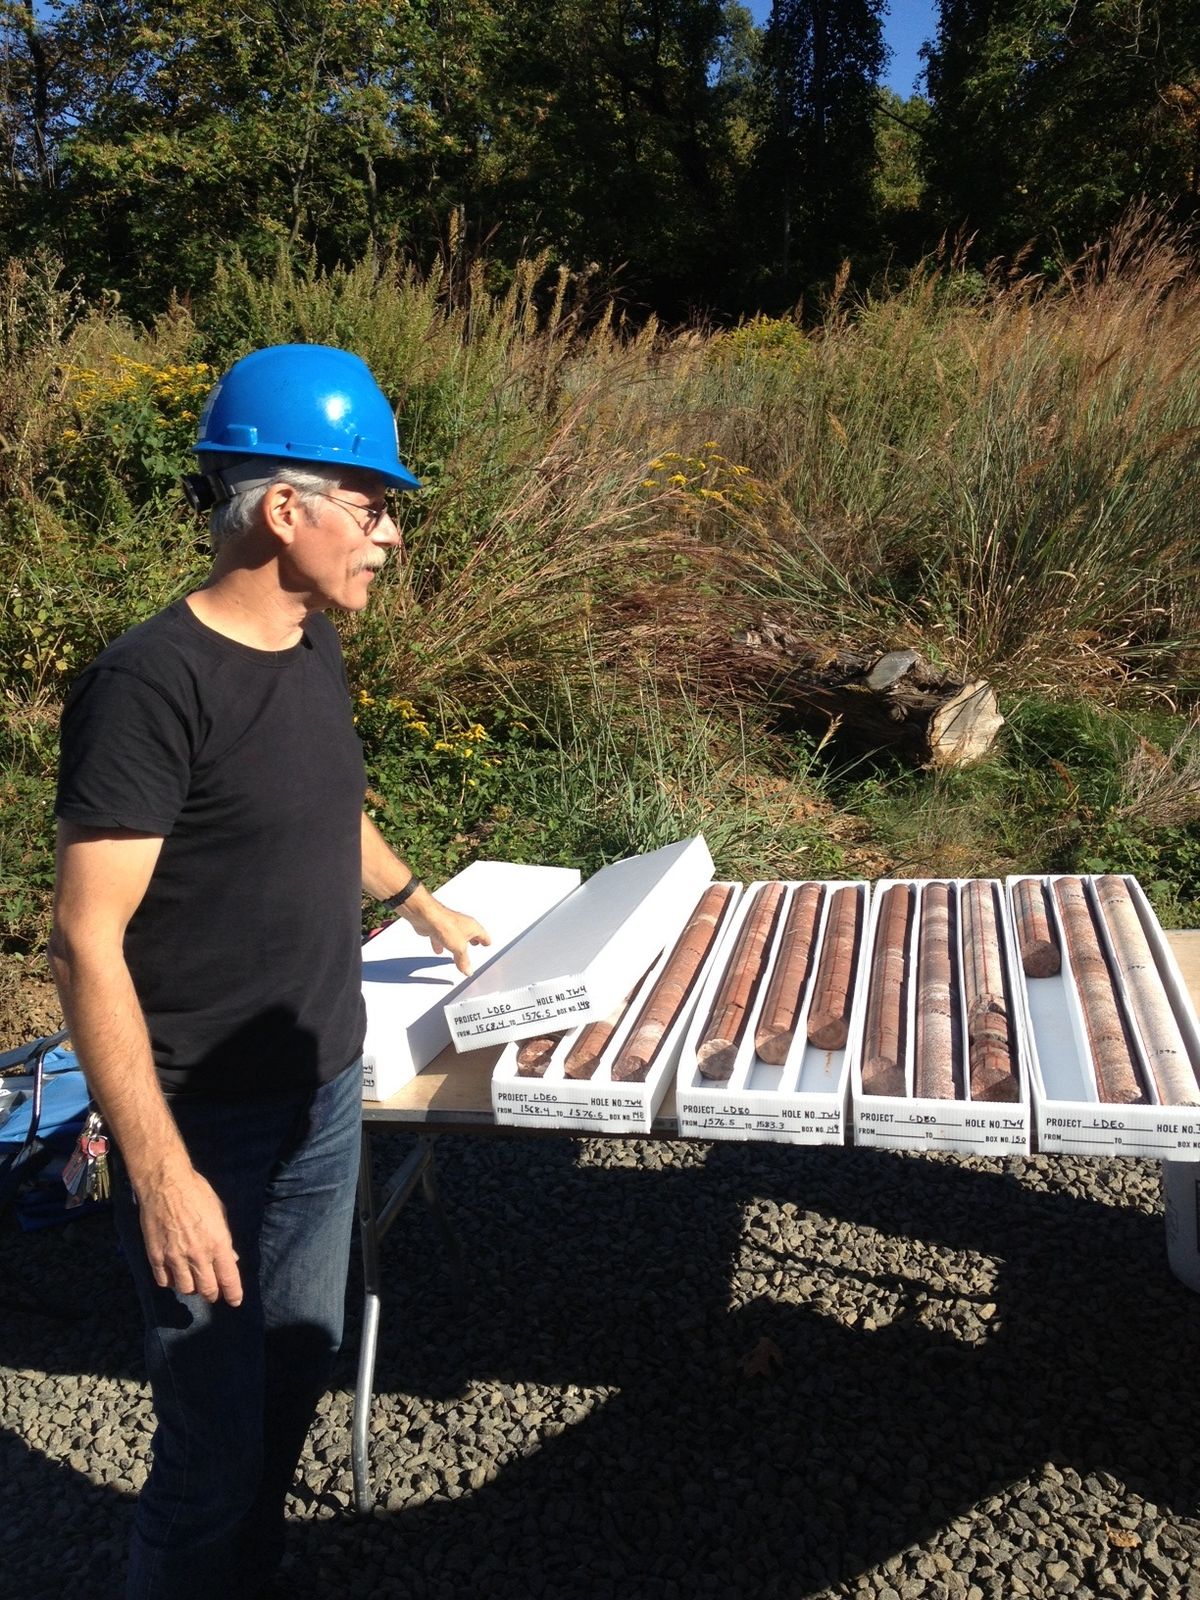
446, 834, 712, 1050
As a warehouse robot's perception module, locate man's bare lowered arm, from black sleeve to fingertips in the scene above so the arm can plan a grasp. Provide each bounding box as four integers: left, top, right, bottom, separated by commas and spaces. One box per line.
50, 822, 242, 1306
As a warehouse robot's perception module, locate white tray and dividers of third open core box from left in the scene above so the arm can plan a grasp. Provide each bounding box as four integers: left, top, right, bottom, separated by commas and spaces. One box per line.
851, 878, 1032, 1155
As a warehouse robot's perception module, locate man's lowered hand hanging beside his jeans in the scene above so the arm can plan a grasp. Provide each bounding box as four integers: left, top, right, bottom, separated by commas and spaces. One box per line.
138, 1166, 242, 1306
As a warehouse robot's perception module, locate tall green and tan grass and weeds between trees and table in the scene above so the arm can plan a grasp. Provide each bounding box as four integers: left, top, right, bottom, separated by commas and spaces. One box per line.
0, 222, 1200, 949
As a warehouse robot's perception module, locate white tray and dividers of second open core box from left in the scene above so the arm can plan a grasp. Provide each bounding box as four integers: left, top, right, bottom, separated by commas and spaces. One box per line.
675, 878, 869, 1144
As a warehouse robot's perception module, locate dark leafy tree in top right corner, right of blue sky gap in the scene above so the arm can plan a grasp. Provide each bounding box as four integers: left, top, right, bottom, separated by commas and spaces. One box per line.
926, 0, 1200, 254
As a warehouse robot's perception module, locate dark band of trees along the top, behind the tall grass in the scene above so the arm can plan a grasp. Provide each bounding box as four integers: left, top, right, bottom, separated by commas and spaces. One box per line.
0, 0, 1200, 320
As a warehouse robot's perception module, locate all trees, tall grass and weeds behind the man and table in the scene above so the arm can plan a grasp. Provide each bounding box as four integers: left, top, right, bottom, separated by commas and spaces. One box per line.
0, 0, 1200, 950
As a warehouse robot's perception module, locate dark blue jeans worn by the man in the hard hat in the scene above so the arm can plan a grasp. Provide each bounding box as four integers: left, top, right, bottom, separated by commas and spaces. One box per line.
114, 1062, 362, 1600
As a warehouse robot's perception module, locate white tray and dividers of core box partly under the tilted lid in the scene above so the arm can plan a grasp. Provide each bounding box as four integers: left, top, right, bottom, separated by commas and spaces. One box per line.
491, 880, 742, 1133
